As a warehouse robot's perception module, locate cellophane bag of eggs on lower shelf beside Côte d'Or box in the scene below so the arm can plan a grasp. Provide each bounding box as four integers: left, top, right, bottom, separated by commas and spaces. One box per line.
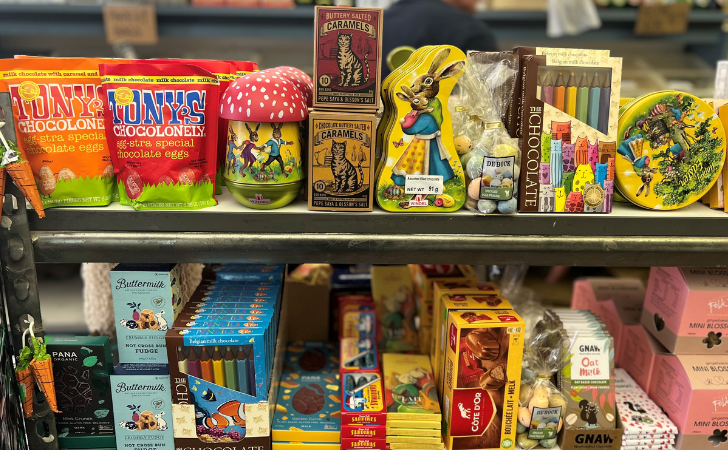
516, 314, 571, 450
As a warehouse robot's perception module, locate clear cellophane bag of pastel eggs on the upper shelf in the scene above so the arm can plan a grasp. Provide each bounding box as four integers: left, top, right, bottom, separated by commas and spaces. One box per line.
455, 52, 521, 214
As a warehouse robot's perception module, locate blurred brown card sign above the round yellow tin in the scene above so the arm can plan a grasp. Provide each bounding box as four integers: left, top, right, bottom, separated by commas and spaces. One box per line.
634, 2, 693, 36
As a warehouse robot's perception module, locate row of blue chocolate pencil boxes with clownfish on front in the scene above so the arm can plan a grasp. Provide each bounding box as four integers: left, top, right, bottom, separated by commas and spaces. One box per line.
165, 270, 286, 450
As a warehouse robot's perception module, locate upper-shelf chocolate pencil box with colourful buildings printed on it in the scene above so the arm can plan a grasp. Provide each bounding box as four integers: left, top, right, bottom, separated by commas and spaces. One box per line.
515, 47, 622, 213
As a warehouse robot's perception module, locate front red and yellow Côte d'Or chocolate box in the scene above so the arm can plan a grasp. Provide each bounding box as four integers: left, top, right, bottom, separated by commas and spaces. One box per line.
443, 310, 525, 450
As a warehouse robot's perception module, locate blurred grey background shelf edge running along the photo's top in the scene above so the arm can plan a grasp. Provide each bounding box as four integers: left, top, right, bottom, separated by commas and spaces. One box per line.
0, 3, 728, 62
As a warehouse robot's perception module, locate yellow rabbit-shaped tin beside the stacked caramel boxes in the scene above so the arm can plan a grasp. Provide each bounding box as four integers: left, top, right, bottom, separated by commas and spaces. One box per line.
377, 46, 466, 212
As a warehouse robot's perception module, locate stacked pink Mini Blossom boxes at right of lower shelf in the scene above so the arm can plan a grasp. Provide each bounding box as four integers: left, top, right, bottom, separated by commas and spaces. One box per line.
572, 267, 728, 450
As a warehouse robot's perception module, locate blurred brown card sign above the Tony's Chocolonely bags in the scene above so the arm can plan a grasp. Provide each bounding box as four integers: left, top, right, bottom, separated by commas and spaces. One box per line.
104, 5, 159, 45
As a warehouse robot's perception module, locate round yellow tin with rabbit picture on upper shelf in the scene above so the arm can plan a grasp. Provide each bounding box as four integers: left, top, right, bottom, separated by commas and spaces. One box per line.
615, 91, 725, 210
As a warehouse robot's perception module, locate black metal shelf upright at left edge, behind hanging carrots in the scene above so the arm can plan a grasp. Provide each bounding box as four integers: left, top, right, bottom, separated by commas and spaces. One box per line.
0, 174, 58, 450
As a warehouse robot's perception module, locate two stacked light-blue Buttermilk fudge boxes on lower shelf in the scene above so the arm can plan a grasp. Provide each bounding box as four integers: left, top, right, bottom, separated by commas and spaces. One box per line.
110, 264, 185, 450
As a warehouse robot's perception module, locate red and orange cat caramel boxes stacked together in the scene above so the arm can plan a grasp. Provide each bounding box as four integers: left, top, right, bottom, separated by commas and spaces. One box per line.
308, 6, 383, 211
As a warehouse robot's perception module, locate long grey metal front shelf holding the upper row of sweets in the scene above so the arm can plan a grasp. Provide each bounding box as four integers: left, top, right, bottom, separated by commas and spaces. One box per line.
30, 194, 728, 267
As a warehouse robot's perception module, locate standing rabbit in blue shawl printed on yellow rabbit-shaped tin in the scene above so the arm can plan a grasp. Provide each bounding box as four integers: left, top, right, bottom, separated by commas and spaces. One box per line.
392, 48, 465, 186
